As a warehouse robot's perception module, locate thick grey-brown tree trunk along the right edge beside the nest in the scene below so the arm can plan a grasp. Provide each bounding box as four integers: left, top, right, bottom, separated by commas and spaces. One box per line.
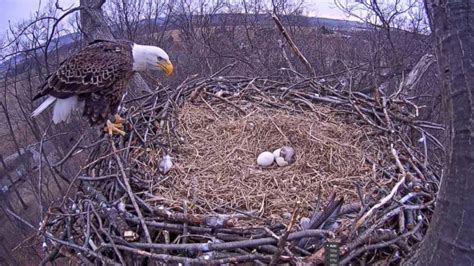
410, 0, 474, 265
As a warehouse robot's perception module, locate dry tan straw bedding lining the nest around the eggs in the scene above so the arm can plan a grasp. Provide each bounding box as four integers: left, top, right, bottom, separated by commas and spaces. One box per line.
149, 102, 380, 223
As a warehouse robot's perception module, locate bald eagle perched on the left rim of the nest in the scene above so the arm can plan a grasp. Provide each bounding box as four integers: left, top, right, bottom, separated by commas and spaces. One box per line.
32, 40, 173, 135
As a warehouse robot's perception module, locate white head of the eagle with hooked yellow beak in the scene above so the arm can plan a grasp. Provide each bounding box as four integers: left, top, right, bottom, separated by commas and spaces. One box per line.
132, 43, 173, 76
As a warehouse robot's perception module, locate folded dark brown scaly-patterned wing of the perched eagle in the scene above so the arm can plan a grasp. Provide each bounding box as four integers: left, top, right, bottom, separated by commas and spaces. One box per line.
33, 41, 133, 99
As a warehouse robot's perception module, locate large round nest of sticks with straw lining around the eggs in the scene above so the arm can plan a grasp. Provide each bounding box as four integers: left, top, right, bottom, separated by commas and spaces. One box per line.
41, 72, 442, 264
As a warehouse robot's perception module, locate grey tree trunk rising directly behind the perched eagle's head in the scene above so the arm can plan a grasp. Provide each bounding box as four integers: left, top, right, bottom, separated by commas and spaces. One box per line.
79, 0, 151, 97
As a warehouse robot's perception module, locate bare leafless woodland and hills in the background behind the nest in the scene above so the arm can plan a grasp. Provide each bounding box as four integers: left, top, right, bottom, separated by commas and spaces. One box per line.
0, 0, 460, 262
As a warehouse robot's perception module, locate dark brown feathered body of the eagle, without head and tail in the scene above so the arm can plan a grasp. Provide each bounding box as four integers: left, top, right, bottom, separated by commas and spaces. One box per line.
33, 40, 133, 124
